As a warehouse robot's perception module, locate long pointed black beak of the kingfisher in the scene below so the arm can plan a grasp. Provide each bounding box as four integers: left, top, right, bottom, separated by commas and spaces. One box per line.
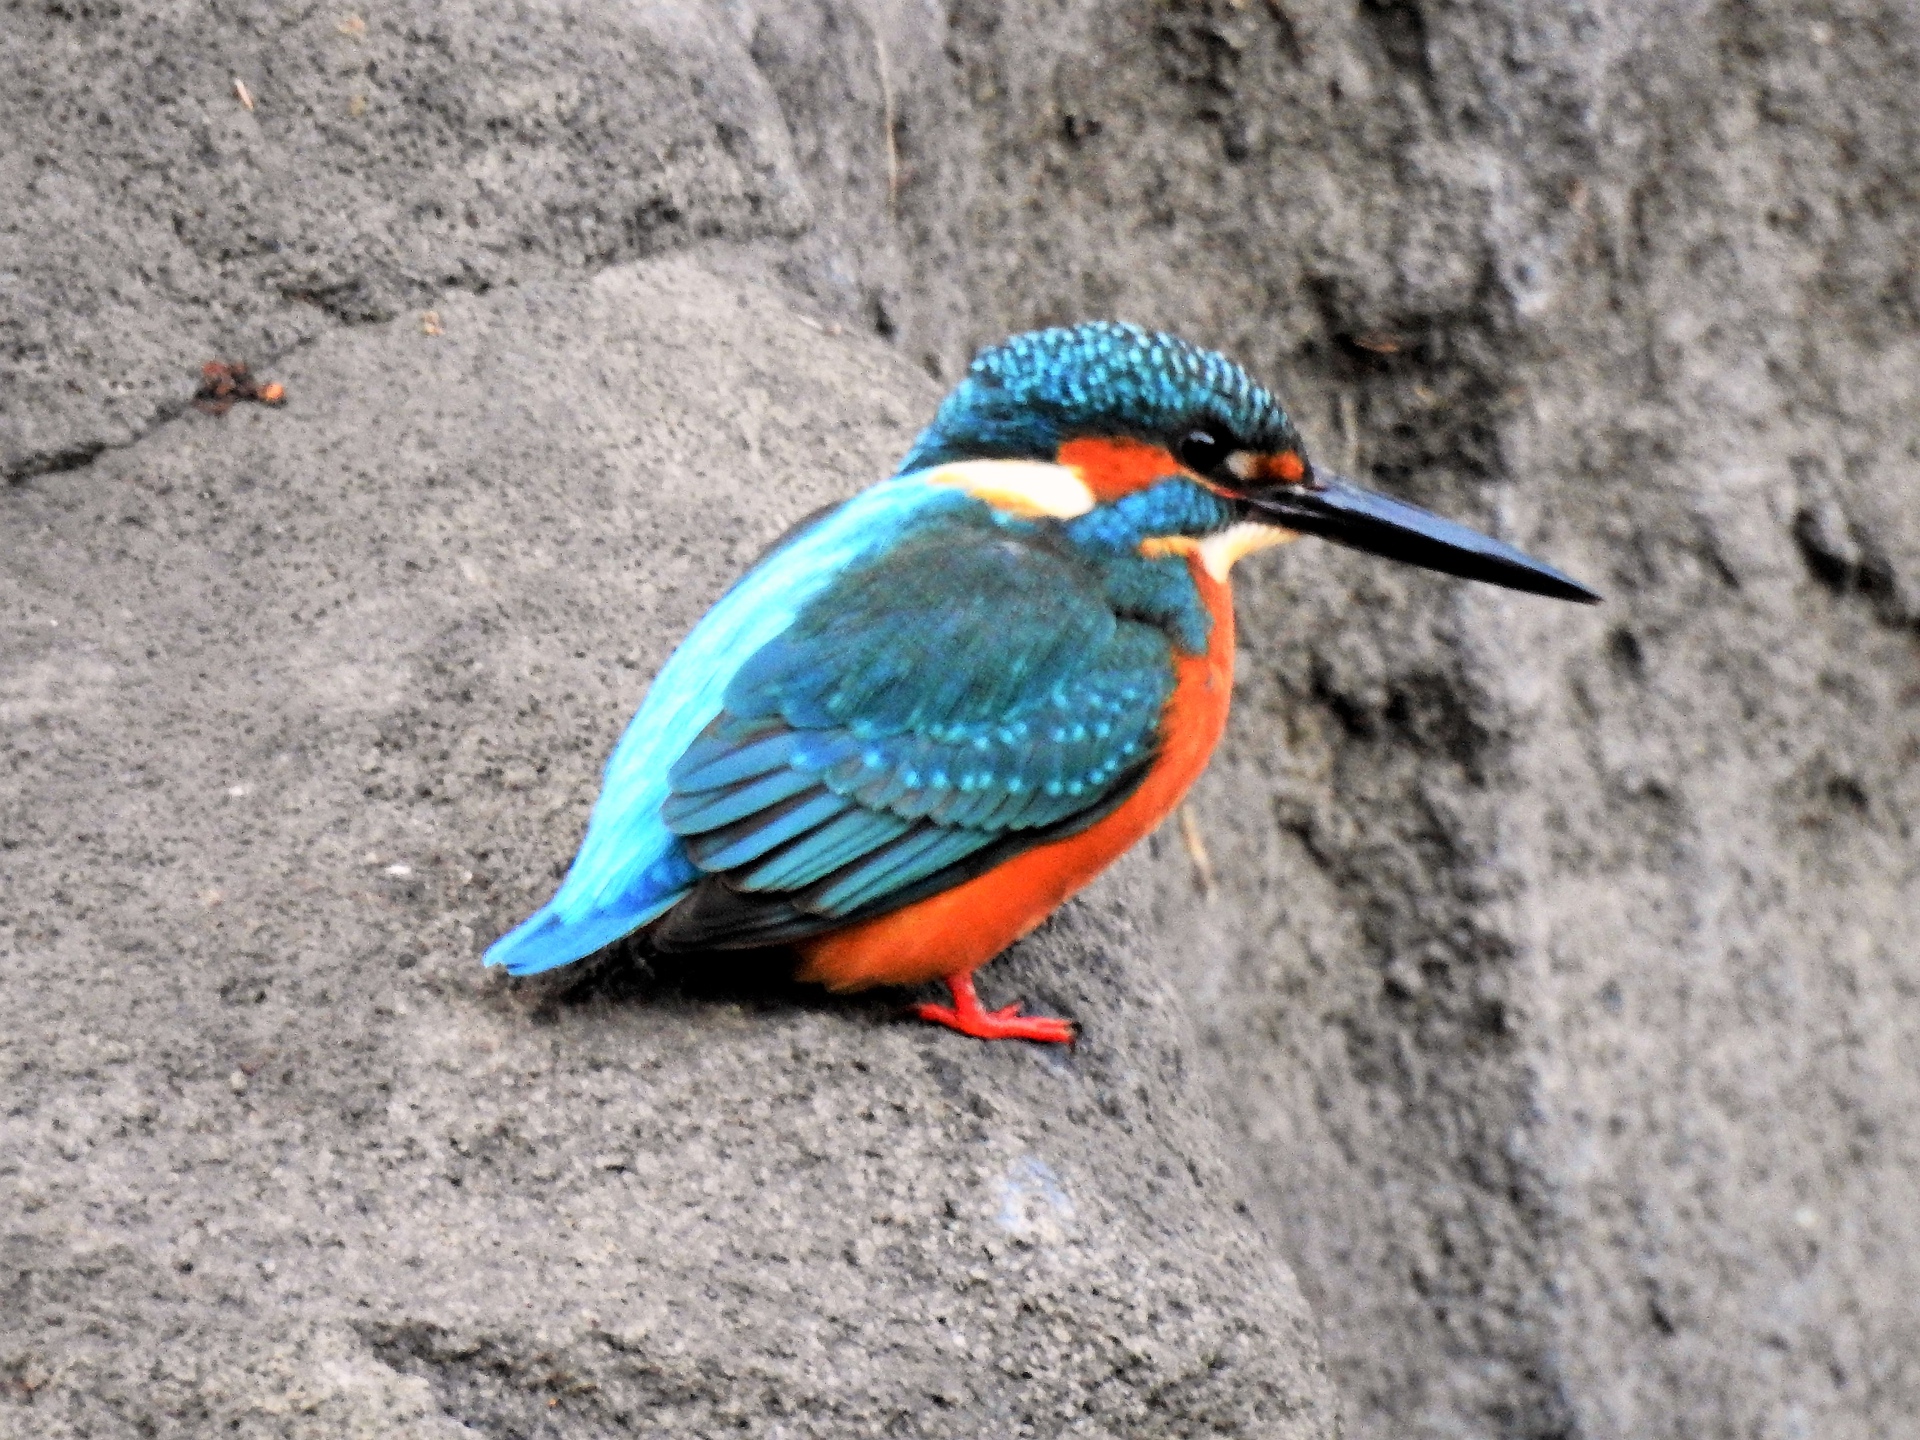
1248, 465, 1599, 605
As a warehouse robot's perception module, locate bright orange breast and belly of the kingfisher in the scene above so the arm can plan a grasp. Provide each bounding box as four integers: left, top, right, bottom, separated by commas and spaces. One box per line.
799, 555, 1233, 991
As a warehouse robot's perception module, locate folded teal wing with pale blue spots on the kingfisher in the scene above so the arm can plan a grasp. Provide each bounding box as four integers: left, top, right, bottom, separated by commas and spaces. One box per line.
649, 507, 1175, 950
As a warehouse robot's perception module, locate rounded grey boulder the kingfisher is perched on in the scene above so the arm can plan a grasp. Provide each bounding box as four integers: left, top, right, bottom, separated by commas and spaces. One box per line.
0, 261, 1332, 1438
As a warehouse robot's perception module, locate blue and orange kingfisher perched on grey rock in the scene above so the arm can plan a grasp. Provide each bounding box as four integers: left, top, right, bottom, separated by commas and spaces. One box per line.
484, 321, 1599, 1043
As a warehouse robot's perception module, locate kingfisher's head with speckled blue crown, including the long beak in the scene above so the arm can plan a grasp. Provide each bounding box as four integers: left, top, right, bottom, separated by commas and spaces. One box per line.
900, 321, 1599, 603
